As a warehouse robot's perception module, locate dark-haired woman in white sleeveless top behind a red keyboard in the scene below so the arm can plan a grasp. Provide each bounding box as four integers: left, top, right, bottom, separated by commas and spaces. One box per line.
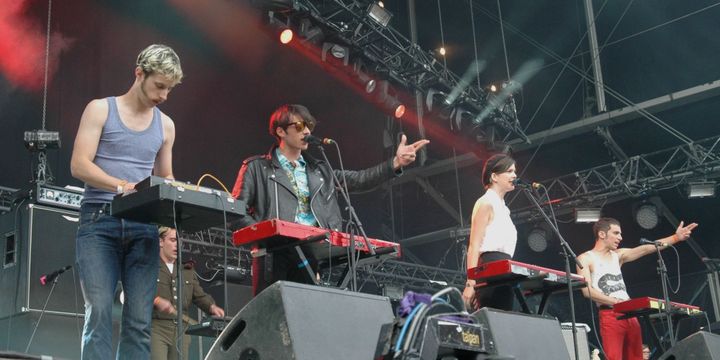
463, 154, 517, 310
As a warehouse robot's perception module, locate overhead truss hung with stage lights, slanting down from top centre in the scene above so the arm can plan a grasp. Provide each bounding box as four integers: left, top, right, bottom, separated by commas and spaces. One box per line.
272, 0, 529, 143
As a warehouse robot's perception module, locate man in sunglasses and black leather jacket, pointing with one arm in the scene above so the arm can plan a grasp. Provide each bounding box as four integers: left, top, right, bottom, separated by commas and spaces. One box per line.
233, 105, 430, 295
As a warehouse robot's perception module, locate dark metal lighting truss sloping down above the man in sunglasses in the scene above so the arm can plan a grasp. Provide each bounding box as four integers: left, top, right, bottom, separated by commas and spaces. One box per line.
278, 0, 529, 142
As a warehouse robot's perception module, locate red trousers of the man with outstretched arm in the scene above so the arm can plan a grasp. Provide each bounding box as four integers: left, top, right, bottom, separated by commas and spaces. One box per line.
599, 309, 642, 360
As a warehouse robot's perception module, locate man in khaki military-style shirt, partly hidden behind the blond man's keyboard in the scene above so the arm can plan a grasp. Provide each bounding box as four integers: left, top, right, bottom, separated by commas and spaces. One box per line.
150, 227, 225, 360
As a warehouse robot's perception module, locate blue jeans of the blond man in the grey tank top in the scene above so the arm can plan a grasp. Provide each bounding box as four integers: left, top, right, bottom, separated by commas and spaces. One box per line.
75, 203, 160, 360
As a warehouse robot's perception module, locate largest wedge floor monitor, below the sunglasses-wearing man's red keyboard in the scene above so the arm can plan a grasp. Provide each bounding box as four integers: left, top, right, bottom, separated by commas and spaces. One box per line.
205, 281, 394, 360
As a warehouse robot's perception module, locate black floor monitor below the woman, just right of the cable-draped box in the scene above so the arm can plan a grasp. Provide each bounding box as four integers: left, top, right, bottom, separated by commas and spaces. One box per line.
474, 308, 570, 360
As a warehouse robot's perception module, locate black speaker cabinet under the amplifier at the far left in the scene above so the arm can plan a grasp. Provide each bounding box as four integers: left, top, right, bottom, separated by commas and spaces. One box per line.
0, 204, 84, 318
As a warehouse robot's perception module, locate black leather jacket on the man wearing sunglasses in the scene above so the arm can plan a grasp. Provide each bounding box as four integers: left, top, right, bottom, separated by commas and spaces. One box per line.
233, 146, 400, 230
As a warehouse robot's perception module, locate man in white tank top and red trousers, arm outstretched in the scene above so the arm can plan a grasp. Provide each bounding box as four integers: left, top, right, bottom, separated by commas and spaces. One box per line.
577, 218, 698, 360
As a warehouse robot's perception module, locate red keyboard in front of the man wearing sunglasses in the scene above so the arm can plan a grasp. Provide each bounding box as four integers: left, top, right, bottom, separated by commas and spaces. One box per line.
233, 219, 400, 259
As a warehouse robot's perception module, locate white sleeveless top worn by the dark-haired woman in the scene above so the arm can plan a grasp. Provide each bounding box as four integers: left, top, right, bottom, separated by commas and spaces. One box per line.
472, 189, 517, 257
